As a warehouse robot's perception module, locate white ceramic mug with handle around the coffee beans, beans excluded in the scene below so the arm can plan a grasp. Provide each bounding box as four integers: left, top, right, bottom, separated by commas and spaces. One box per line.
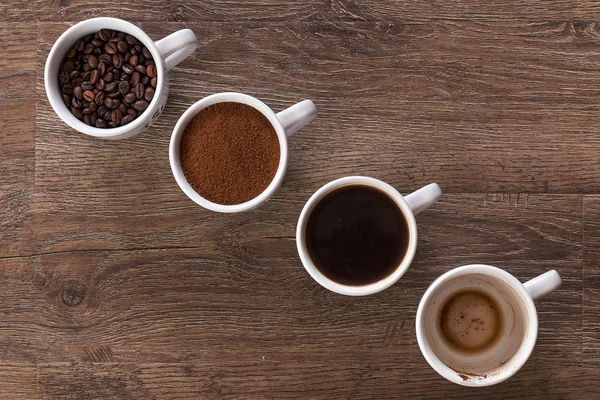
44, 18, 197, 139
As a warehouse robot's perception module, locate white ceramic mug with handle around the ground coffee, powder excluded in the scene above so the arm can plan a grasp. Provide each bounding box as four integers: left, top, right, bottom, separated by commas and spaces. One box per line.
169, 93, 317, 213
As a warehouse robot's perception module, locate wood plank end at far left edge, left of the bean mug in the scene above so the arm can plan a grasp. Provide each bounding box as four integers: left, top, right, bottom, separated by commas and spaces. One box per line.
0, 23, 37, 257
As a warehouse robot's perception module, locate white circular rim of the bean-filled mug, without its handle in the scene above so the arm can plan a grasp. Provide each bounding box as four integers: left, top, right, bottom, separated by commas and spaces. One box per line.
44, 17, 167, 139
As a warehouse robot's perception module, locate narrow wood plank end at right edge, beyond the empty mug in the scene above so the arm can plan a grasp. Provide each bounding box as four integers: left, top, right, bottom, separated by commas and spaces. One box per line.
582, 196, 600, 369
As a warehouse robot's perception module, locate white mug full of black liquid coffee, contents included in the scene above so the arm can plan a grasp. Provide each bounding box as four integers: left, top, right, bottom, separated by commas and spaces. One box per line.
296, 176, 442, 296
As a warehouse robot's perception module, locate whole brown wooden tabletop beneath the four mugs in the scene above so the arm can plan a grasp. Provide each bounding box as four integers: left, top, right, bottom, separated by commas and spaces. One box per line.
0, 0, 600, 400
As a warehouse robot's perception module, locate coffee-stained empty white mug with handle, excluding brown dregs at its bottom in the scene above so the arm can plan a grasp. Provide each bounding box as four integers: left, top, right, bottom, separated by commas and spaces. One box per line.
416, 264, 561, 386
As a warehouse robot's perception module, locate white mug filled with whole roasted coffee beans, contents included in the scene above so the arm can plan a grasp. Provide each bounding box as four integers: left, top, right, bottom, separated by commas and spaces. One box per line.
44, 18, 197, 139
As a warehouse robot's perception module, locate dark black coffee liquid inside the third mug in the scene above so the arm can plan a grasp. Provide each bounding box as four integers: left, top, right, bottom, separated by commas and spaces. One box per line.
305, 185, 409, 286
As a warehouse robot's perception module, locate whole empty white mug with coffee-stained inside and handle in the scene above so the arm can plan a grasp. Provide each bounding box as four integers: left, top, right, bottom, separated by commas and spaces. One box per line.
416, 264, 561, 386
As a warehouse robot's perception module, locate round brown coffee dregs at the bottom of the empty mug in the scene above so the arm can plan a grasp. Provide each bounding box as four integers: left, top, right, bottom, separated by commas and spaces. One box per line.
439, 289, 504, 354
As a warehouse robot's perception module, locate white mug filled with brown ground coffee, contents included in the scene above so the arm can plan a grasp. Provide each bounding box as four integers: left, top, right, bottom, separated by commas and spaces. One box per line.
169, 93, 317, 213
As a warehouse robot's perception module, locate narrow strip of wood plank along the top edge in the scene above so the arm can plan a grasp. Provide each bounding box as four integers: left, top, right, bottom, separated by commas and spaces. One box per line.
0, 0, 600, 22
